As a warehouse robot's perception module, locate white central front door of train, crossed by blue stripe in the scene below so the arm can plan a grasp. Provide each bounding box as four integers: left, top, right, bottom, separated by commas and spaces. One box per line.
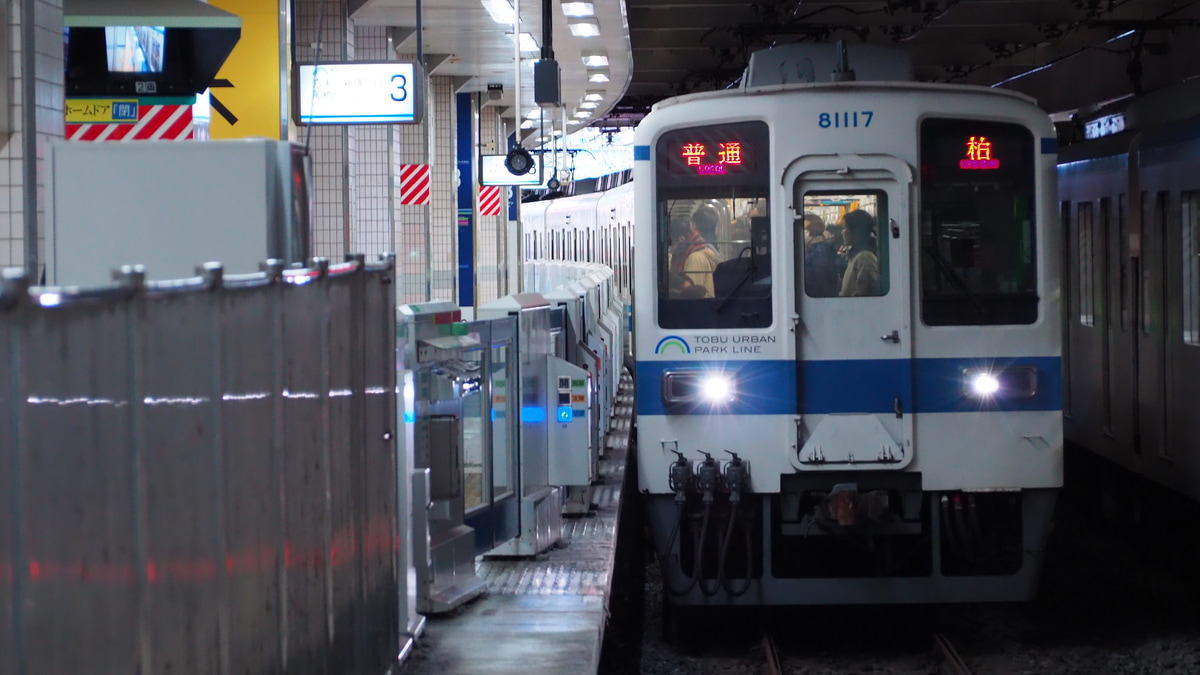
784, 155, 913, 471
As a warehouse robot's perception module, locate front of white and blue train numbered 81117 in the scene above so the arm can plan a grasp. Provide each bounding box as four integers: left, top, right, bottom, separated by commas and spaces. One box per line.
527, 44, 1063, 607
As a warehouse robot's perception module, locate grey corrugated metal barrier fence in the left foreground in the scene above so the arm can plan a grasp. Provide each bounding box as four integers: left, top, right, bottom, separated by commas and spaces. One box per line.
0, 256, 407, 675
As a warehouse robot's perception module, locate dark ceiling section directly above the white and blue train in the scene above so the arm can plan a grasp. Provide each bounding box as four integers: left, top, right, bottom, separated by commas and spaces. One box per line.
614, 0, 1200, 126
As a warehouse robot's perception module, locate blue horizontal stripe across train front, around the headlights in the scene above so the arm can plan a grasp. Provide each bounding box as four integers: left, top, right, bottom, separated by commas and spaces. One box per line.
637, 357, 1062, 414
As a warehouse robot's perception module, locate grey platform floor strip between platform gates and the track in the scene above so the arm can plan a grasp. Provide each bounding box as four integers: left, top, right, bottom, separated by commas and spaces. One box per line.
400, 374, 636, 675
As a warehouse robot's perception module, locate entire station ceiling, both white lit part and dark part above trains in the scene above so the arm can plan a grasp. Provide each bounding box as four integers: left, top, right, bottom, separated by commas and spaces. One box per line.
348, 0, 1200, 136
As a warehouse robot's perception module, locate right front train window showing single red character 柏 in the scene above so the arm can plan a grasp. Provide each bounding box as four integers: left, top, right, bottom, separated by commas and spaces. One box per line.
920, 119, 1038, 325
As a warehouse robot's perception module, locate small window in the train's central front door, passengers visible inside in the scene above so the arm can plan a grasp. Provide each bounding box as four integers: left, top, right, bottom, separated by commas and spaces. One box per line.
796, 190, 889, 298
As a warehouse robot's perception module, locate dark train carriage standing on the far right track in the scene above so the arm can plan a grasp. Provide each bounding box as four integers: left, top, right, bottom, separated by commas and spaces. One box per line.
1058, 83, 1200, 500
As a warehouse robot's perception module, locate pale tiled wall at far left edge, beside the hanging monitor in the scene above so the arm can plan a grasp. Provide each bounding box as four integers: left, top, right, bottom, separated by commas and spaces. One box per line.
0, 0, 64, 273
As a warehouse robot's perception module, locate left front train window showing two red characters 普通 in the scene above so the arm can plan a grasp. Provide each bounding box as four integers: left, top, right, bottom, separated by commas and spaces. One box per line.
655, 121, 772, 328
